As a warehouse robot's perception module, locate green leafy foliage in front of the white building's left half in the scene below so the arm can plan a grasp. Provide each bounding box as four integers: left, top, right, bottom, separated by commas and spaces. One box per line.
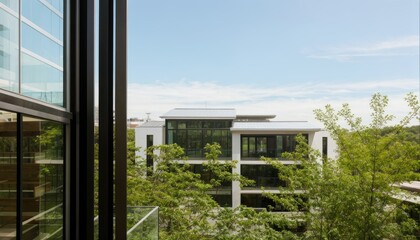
128, 144, 293, 239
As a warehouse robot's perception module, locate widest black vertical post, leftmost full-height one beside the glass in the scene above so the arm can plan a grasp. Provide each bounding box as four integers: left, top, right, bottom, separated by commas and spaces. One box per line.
70, 0, 95, 239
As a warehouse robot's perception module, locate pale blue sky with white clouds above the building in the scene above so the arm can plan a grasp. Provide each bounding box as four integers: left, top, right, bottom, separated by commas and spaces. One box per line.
128, 0, 420, 126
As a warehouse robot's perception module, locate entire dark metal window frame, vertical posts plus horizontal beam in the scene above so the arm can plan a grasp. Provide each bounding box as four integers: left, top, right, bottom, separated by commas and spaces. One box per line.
0, 0, 127, 239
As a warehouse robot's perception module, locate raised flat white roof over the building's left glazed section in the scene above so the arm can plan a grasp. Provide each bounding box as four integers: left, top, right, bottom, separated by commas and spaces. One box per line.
160, 108, 236, 120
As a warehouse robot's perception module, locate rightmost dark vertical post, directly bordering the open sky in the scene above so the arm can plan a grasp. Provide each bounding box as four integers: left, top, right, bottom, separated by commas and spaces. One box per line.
115, 0, 127, 240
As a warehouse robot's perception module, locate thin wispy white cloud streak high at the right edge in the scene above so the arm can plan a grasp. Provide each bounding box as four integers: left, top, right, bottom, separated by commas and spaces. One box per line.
308, 35, 420, 61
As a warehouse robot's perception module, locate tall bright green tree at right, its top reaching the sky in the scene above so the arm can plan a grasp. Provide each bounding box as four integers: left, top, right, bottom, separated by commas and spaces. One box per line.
266, 94, 420, 239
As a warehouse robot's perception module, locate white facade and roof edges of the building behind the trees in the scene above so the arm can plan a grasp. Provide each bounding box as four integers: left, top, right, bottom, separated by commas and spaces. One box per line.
136, 108, 337, 208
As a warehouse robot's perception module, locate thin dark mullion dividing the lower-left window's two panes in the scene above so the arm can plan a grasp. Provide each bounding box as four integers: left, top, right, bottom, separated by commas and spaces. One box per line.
16, 113, 23, 240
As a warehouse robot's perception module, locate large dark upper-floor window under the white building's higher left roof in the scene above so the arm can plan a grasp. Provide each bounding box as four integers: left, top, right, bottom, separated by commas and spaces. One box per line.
166, 120, 232, 158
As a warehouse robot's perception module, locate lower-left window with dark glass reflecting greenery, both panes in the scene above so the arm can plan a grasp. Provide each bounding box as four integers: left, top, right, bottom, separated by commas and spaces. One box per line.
0, 111, 64, 239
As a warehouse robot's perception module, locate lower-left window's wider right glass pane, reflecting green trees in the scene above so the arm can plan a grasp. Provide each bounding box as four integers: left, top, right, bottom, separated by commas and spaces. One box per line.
22, 117, 64, 239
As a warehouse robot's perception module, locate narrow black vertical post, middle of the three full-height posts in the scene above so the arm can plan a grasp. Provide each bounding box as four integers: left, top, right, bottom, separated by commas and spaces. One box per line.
98, 0, 114, 237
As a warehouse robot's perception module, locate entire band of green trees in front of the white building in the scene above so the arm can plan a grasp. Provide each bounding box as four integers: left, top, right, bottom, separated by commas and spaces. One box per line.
123, 94, 420, 239
